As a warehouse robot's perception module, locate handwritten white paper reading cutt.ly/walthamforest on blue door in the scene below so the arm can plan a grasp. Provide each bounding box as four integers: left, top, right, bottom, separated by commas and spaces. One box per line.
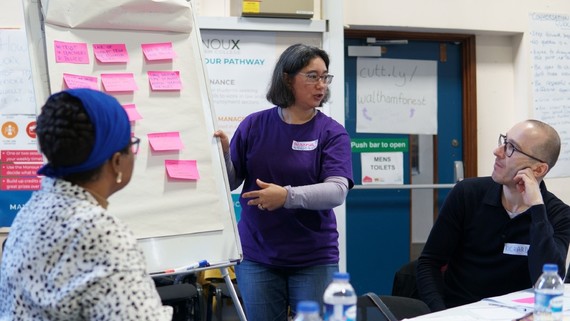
356, 58, 437, 135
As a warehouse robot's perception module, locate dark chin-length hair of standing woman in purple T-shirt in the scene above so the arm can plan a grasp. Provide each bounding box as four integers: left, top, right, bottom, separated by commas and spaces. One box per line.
265, 43, 330, 108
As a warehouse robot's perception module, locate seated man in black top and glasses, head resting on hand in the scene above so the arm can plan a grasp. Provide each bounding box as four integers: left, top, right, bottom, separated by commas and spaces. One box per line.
417, 120, 570, 311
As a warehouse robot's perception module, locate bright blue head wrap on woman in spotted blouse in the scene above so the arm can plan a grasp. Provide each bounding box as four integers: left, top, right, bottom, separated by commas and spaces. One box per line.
38, 89, 131, 177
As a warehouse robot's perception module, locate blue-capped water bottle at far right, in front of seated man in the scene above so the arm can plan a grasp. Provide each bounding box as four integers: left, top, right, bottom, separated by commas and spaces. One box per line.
533, 264, 564, 321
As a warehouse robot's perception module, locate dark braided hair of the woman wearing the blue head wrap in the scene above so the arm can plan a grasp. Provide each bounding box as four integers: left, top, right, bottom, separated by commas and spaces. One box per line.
36, 92, 129, 183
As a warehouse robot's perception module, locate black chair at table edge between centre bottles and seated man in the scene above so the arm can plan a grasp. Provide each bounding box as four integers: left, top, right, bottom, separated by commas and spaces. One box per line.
357, 292, 431, 321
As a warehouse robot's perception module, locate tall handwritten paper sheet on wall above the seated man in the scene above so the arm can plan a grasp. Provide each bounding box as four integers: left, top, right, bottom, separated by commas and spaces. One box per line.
529, 13, 570, 177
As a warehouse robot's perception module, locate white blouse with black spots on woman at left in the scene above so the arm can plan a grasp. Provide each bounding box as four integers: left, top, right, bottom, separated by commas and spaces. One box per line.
0, 177, 172, 321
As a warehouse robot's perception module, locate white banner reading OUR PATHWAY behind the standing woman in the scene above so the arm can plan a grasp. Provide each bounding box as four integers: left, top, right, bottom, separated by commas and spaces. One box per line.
201, 30, 277, 137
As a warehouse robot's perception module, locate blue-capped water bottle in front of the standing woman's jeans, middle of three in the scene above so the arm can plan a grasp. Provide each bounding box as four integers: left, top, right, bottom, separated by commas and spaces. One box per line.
323, 272, 357, 321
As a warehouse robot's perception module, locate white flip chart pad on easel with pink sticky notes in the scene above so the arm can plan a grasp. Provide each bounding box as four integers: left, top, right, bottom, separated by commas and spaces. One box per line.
38, 0, 242, 272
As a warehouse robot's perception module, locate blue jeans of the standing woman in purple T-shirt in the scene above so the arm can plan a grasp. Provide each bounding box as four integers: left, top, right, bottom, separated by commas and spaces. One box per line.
236, 260, 338, 321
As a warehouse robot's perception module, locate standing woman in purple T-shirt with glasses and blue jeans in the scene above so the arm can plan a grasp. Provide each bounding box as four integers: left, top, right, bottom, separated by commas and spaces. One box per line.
215, 44, 354, 321
